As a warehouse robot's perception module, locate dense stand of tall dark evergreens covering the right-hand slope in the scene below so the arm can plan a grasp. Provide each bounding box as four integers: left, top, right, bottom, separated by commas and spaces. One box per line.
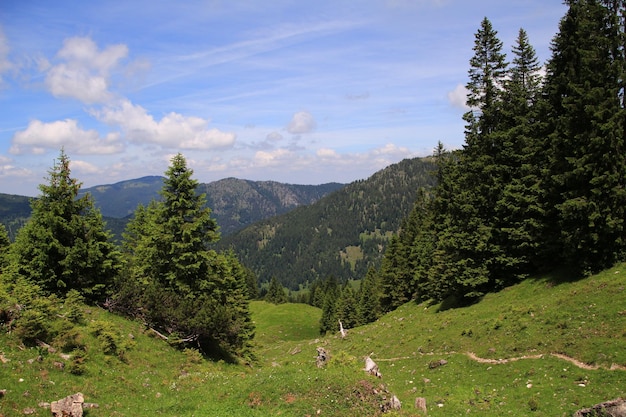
278, 0, 626, 332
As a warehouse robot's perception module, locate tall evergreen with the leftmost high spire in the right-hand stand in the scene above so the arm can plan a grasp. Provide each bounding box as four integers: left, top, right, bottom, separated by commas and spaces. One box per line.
431, 18, 511, 301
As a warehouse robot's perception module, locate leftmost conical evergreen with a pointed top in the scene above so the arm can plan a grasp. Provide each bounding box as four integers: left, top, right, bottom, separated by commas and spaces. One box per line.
11, 150, 120, 301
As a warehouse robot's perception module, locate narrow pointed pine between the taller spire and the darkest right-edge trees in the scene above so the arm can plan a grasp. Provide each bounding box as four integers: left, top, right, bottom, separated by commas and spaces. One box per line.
493, 29, 545, 276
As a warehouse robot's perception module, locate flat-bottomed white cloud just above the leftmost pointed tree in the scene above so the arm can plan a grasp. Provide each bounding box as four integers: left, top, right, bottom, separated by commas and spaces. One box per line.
9, 119, 124, 154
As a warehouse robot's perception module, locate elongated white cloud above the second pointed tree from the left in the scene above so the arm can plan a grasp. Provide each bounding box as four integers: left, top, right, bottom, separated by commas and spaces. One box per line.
91, 100, 235, 150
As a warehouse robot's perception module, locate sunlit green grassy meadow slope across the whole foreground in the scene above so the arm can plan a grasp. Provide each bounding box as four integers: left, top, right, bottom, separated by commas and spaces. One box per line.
0, 264, 626, 417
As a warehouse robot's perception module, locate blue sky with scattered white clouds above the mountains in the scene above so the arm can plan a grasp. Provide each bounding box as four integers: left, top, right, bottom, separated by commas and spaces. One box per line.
0, 0, 566, 196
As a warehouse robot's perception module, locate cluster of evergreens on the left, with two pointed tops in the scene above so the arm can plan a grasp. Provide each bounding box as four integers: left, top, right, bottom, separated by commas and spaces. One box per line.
0, 151, 256, 360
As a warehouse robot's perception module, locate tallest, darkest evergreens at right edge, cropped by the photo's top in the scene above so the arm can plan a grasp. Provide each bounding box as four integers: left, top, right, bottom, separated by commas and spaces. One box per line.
544, 0, 626, 273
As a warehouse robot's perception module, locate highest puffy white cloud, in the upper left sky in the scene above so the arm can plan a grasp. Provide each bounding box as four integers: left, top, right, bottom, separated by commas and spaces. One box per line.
46, 37, 128, 104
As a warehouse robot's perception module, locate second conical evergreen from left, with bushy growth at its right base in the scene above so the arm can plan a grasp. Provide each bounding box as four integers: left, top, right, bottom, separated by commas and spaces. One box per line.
116, 154, 254, 359
